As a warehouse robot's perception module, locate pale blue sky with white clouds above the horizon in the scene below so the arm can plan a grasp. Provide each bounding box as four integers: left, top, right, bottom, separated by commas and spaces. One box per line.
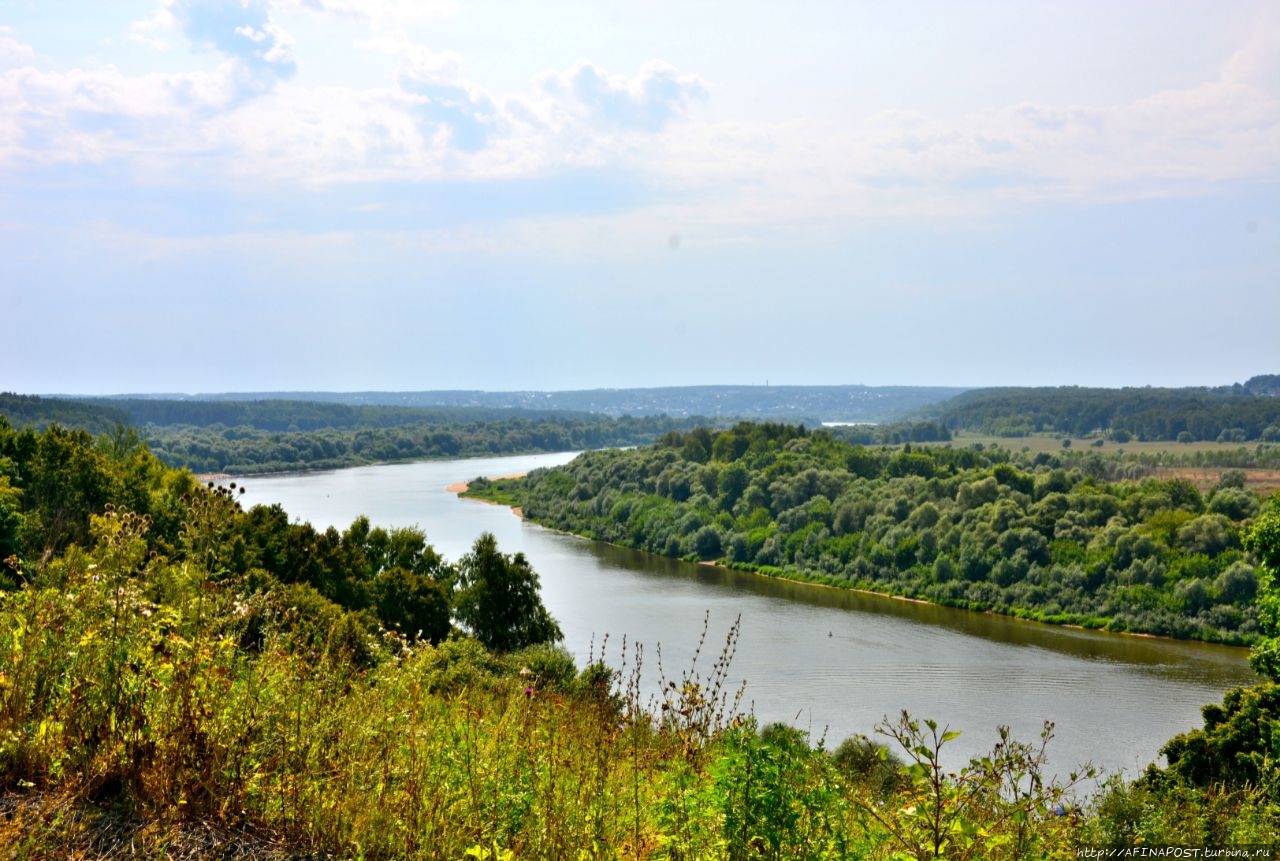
0, 0, 1280, 394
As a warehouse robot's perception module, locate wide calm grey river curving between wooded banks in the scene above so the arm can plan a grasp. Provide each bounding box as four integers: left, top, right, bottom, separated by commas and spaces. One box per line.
232, 454, 1256, 775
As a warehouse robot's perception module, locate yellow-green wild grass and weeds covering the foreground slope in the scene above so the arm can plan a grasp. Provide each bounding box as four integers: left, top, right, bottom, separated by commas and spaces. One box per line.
0, 512, 1276, 861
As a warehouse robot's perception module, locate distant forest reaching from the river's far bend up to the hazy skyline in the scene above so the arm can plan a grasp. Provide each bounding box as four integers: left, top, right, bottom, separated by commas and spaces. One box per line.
0, 375, 1280, 475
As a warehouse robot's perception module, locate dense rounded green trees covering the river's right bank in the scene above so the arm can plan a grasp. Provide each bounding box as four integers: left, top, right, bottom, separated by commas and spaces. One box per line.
474, 423, 1261, 644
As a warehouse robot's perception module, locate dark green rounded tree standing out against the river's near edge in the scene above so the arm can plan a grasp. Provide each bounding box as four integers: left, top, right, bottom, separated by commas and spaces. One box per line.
453, 532, 564, 651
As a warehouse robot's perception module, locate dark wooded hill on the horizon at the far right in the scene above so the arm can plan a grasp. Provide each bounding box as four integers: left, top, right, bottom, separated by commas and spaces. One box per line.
938, 375, 1280, 443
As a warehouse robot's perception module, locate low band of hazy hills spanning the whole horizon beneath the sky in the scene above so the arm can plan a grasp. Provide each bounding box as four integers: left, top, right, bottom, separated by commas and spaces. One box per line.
15, 375, 1280, 441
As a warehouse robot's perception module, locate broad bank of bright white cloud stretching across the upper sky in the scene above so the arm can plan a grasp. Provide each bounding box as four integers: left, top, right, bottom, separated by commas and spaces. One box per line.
0, 0, 1280, 248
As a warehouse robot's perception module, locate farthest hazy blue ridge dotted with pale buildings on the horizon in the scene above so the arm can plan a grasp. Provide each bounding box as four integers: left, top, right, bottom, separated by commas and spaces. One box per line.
87, 385, 965, 425
